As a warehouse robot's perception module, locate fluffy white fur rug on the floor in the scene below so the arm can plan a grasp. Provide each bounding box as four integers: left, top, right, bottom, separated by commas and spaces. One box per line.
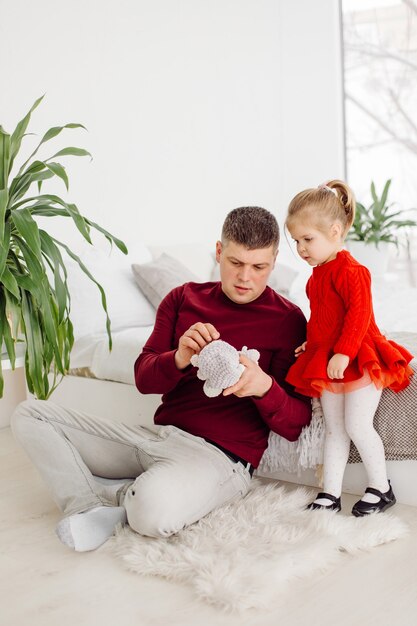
108, 479, 407, 611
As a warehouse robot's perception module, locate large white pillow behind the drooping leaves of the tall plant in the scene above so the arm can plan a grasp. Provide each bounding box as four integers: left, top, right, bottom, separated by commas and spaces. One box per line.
66, 243, 155, 339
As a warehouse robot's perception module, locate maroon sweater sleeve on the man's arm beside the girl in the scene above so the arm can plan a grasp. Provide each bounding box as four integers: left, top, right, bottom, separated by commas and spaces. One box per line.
253, 309, 311, 441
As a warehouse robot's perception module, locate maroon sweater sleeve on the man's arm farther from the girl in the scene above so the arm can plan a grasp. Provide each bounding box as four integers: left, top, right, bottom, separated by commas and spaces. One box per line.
134, 287, 191, 394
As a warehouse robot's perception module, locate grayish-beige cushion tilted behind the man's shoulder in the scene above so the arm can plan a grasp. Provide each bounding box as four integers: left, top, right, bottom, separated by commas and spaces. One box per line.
132, 253, 200, 309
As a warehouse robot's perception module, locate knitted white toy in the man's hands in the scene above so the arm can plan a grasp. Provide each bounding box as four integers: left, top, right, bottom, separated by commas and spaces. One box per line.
191, 339, 260, 398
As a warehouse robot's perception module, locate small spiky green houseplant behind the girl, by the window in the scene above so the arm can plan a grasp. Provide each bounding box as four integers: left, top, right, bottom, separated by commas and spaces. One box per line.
347, 180, 417, 248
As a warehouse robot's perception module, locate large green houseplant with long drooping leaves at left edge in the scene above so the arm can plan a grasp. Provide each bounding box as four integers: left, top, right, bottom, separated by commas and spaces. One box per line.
0, 96, 127, 399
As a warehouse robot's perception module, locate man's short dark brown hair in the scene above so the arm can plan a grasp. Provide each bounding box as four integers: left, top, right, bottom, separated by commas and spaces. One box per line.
222, 206, 279, 251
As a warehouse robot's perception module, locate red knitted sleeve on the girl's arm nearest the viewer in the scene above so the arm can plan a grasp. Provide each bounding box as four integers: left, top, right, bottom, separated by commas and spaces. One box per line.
333, 266, 372, 360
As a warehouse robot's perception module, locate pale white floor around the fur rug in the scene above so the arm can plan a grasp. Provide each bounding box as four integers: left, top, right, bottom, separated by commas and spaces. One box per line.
0, 428, 417, 626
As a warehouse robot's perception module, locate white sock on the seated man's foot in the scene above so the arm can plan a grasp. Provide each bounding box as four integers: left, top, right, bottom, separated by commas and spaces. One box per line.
55, 506, 126, 552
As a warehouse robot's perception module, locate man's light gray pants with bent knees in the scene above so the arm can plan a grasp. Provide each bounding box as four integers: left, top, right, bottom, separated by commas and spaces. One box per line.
11, 400, 250, 537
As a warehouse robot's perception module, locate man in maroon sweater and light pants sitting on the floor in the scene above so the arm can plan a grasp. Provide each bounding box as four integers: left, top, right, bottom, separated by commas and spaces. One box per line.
12, 207, 311, 551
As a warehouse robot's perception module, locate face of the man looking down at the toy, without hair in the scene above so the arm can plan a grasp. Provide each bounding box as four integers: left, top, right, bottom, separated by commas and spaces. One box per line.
216, 241, 277, 304
